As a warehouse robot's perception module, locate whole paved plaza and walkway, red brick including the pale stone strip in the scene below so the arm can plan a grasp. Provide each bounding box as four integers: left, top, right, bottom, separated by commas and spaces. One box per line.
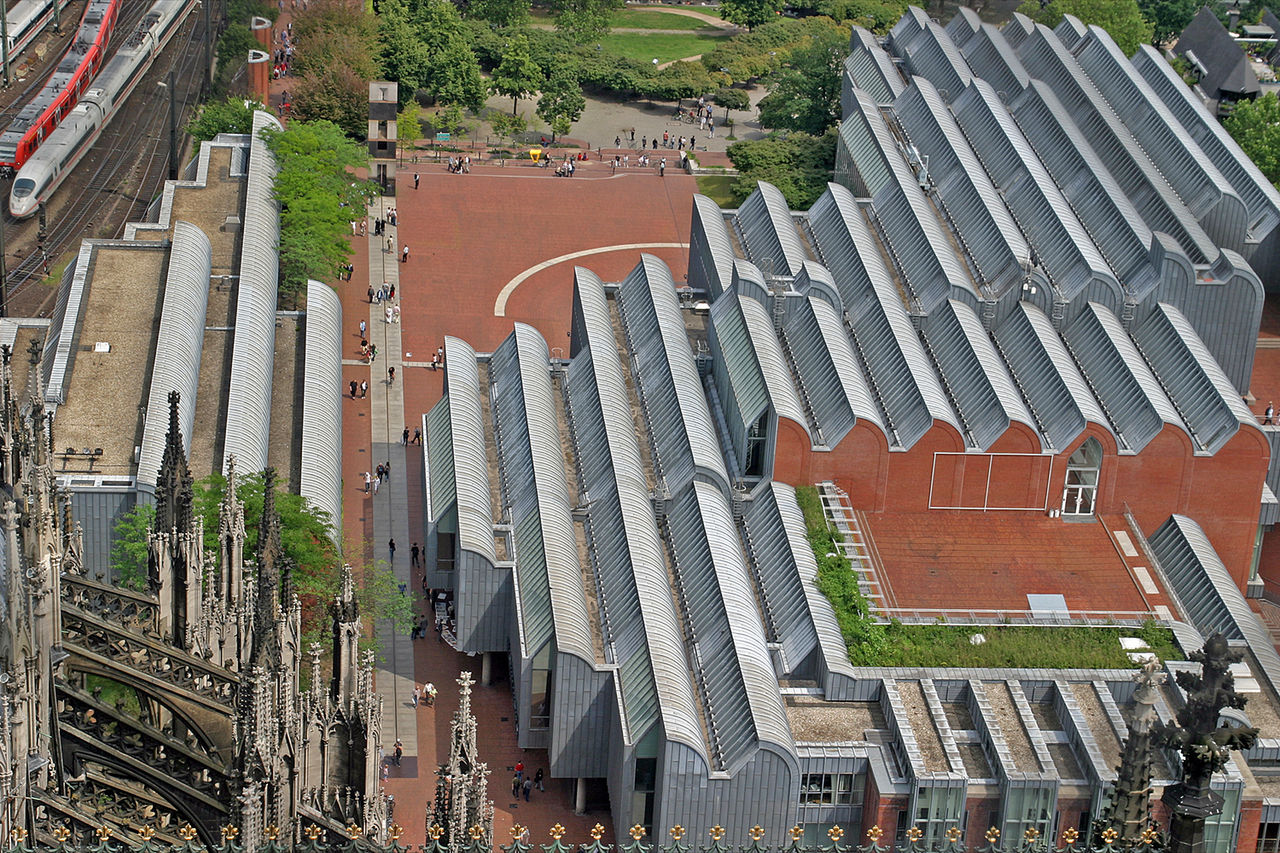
335, 161, 696, 844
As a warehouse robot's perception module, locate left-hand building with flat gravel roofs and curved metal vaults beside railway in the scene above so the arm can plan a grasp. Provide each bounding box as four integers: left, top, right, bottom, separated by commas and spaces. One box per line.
35, 113, 342, 576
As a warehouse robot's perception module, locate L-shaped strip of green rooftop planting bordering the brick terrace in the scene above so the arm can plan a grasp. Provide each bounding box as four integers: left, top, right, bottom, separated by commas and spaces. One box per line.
796, 487, 1184, 670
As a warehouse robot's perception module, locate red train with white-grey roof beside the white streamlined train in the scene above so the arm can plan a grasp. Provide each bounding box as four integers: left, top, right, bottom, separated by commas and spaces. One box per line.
0, 0, 122, 174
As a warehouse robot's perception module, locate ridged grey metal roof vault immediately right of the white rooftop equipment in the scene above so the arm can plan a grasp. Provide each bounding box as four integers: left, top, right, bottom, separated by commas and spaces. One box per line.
893, 77, 1030, 292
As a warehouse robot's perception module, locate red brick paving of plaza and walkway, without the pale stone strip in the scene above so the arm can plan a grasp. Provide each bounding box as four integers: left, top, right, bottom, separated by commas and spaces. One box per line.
337, 163, 696, 844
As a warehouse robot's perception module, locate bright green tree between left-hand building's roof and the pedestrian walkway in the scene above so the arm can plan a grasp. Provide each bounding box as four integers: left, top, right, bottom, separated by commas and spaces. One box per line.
264, 120, 378, 292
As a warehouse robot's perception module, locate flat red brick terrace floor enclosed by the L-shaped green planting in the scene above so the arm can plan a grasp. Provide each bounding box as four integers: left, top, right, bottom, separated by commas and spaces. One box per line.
867, 510, 1164, 611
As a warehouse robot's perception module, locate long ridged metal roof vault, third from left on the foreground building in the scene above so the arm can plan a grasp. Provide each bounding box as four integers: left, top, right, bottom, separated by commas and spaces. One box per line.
568, 268, 707, 761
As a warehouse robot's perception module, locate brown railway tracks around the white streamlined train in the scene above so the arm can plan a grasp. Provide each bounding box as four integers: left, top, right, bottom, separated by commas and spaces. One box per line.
4, 0, 207, 306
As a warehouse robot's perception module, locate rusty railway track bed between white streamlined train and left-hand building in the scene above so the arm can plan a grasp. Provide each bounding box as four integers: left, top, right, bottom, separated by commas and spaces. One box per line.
0, 0, 207, 316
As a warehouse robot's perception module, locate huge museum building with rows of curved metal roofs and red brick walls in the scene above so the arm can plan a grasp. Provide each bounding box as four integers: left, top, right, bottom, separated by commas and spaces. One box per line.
424, 9, 1280, 853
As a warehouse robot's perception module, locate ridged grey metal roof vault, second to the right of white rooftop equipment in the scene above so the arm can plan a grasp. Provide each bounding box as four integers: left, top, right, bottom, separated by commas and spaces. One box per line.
952, 78, 1123, 305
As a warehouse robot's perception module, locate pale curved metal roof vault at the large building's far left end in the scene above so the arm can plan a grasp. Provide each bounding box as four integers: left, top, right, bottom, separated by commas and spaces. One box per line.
444, 337, 498, 564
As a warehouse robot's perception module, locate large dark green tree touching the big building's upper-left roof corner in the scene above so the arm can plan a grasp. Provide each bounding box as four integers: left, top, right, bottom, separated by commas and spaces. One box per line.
759, 29, 849, 134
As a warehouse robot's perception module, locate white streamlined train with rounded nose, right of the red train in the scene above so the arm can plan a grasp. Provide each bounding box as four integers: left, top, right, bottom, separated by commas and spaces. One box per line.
9, 0, 198, 219
